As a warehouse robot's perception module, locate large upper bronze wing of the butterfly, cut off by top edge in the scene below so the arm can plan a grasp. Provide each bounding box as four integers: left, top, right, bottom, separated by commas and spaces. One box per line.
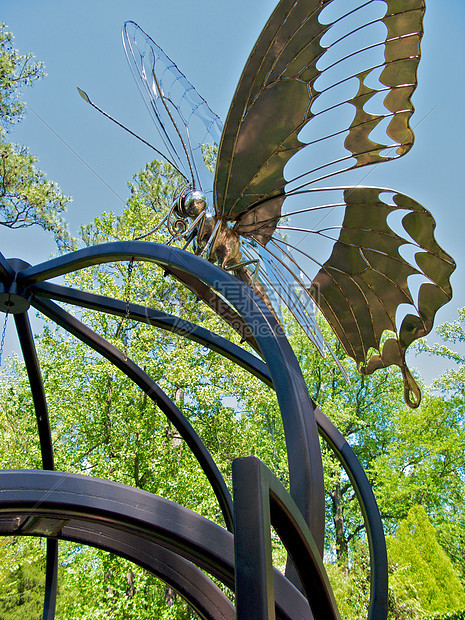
215, 0, 424, 220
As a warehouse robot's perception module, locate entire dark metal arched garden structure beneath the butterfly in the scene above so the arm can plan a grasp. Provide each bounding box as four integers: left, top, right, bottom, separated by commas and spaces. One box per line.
0, 241, 387, 620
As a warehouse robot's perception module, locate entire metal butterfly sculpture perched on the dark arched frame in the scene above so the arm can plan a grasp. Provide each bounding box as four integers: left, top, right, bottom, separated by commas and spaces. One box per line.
81, 0, 455, 407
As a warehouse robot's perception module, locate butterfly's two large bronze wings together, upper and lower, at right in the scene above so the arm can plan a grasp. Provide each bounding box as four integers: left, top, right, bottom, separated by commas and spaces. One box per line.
211, 0, 454, 406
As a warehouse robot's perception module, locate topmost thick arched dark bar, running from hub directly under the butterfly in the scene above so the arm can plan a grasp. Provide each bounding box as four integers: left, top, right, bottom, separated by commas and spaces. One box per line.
17, 241, 324, 554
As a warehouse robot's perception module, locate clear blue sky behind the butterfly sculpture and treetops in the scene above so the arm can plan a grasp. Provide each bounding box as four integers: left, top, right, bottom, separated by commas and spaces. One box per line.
0, 0, 465, 379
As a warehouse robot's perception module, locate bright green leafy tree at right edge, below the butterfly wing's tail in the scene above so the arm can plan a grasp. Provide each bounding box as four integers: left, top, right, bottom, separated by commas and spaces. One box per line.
371, 391, 465, 527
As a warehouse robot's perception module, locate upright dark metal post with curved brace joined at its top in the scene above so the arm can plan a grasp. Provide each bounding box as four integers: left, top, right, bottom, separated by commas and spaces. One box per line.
232, 456, 340, 620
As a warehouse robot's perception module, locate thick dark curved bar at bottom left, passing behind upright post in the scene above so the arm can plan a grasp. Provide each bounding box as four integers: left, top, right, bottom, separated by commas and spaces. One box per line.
0, 470, 312, 620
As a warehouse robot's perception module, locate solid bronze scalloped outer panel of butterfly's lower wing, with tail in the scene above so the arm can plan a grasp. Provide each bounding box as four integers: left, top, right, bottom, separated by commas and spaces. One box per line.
314, 187, 455, 407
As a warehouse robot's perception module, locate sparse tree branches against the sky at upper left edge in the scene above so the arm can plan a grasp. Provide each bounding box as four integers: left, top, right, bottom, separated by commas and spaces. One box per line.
0, 25, 73, 247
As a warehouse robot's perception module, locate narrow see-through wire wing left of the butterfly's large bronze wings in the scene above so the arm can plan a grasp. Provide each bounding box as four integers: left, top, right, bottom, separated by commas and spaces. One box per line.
123, 22, 222, 193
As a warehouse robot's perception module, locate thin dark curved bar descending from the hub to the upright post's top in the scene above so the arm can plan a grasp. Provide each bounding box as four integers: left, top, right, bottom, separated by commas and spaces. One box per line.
31, 297, 234, 531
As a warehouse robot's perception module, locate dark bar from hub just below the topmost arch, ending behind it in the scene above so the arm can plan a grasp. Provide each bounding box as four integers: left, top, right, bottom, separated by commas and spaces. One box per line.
32, 282, 272, 386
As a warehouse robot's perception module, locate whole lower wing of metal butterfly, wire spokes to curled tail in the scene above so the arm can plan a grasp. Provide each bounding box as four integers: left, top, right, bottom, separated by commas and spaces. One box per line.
239, 187, 455, 407
